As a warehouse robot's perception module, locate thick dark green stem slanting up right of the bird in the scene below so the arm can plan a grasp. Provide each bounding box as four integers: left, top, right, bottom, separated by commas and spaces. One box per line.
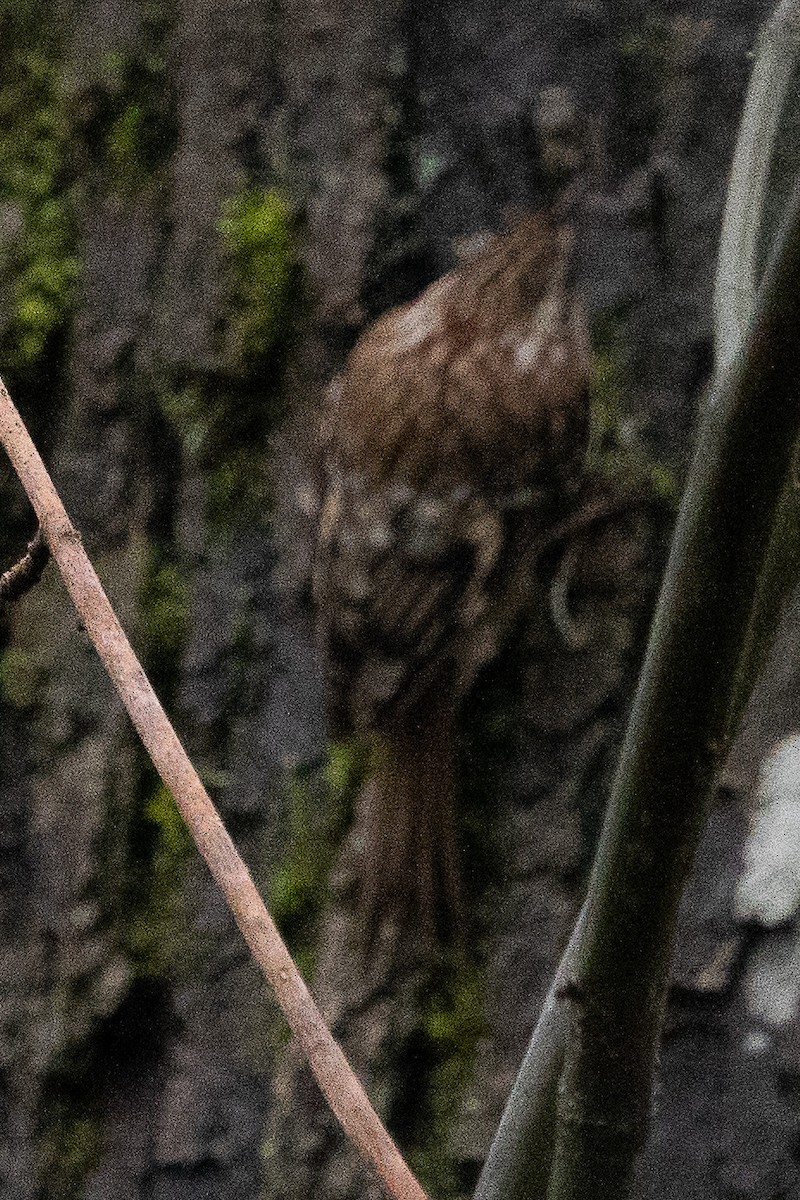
547, 177, 800, 1200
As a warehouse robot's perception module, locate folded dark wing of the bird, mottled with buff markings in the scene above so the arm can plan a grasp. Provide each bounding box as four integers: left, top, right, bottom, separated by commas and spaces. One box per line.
314, 473, 503, 730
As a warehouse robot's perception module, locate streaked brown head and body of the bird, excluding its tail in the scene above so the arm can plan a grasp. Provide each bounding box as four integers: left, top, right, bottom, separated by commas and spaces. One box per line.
314, 208, 590, 730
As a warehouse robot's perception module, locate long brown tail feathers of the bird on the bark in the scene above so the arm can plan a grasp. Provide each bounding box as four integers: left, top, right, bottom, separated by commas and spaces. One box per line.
361, 697, 463, 949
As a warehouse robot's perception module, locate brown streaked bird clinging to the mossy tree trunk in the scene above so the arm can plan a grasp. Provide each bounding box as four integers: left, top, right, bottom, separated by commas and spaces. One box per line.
312, 211, 591, 946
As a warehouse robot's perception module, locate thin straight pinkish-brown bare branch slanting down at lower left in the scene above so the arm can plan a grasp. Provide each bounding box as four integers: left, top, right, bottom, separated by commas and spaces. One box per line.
0, 380, 426, 1200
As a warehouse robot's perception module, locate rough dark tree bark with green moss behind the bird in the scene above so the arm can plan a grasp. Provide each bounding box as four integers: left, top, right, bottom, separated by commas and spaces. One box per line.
0, 0, 800, 1200
